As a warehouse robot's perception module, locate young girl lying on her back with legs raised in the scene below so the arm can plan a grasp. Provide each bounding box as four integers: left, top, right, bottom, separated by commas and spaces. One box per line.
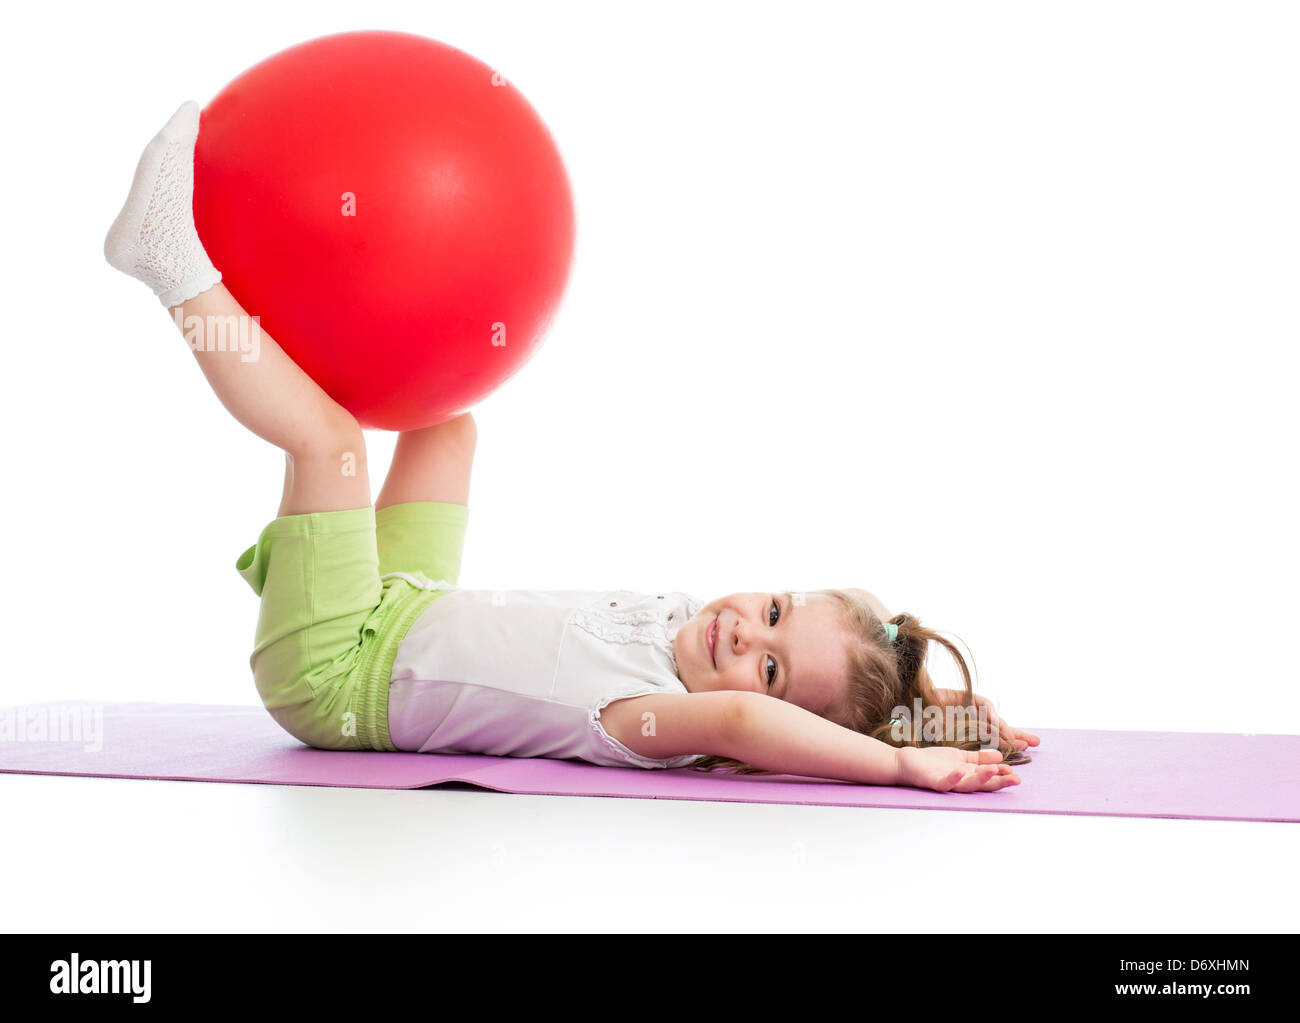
104, 103, 1039, 792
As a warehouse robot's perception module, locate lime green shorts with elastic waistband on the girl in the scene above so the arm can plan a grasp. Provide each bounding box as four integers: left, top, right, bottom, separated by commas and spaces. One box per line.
235, 502, 469, 750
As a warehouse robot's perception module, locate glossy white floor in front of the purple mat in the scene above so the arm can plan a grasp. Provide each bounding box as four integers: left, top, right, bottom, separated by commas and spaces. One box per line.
0, 775, 1300, 930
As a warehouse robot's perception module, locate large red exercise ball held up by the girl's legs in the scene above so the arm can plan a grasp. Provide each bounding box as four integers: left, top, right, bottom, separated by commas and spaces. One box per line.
194, 31, 575, 430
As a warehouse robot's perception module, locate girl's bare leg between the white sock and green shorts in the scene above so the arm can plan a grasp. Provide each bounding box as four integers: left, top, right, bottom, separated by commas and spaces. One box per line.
169, 283, 371, 516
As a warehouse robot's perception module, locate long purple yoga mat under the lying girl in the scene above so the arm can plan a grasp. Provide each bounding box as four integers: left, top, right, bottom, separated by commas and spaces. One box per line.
0, 702, 1300, 822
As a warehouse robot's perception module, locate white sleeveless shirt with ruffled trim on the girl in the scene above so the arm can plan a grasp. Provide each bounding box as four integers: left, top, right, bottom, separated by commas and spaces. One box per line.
389, 587, 707, 768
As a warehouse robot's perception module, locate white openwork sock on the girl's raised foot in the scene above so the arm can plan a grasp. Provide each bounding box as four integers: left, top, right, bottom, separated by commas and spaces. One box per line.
104, 100, 221, 308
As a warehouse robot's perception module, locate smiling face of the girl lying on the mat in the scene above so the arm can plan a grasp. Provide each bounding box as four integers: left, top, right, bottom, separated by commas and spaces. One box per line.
672, 593, 854, 719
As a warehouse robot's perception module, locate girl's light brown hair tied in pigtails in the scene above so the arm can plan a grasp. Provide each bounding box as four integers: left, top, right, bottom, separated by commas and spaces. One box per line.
690, 590, 1015, 775
